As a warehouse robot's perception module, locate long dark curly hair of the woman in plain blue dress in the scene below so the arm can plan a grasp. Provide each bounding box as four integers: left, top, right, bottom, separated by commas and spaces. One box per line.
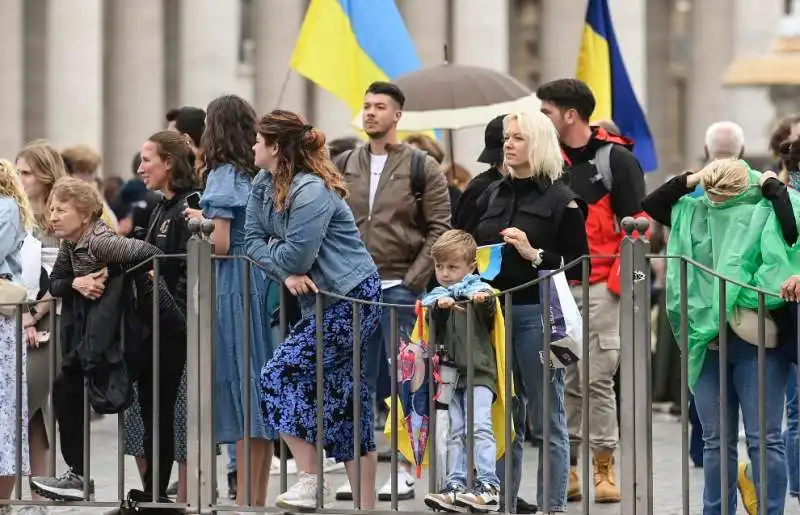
200, 95, 258, 178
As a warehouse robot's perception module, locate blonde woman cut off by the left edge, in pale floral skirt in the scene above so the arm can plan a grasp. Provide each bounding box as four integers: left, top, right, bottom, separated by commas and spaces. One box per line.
0, 159, 34, 513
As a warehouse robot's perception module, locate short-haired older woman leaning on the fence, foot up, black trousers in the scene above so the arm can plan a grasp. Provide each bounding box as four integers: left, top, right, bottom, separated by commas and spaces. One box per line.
30, 177, 185, 508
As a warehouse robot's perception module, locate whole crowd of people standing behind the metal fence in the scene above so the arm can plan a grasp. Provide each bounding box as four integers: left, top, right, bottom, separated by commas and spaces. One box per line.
0, 73, 800, 514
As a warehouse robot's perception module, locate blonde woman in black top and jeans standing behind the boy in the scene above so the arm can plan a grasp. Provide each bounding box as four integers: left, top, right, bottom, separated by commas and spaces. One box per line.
475, 112, 589, 512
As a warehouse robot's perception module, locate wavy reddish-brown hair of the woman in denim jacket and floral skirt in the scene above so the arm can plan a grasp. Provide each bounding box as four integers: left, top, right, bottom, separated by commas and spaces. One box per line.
258, 109, 347, 211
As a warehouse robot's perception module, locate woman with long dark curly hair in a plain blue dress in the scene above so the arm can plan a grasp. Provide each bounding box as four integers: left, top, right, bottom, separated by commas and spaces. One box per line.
187, 95, 275, 506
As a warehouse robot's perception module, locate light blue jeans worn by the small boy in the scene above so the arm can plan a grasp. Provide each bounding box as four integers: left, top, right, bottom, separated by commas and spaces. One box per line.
447, 386, 500, 487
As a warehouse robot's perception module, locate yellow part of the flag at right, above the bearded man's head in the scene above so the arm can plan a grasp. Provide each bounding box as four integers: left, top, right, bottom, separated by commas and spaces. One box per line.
575, 24, 612, 121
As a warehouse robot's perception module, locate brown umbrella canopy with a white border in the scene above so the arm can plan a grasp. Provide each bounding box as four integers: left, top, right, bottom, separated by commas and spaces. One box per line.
353, 64, 540, 131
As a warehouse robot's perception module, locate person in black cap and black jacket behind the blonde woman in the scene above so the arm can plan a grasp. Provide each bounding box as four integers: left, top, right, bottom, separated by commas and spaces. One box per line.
453, 114, 506, 233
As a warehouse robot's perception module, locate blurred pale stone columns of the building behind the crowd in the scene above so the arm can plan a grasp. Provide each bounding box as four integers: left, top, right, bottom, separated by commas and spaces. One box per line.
0, 0, 789, 178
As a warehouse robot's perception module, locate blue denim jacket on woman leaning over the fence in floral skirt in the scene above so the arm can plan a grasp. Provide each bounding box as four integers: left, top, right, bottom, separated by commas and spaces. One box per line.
245, 170, 378, 317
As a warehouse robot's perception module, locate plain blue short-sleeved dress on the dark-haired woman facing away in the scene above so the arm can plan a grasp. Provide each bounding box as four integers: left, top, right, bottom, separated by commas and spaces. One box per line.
200, 165, 276, 443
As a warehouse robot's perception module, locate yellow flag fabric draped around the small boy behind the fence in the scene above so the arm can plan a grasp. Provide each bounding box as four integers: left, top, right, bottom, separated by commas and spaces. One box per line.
383, 299, 514, 468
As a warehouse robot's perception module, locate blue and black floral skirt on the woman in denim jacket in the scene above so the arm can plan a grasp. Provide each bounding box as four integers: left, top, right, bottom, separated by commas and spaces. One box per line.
261, 274, 381, 461
